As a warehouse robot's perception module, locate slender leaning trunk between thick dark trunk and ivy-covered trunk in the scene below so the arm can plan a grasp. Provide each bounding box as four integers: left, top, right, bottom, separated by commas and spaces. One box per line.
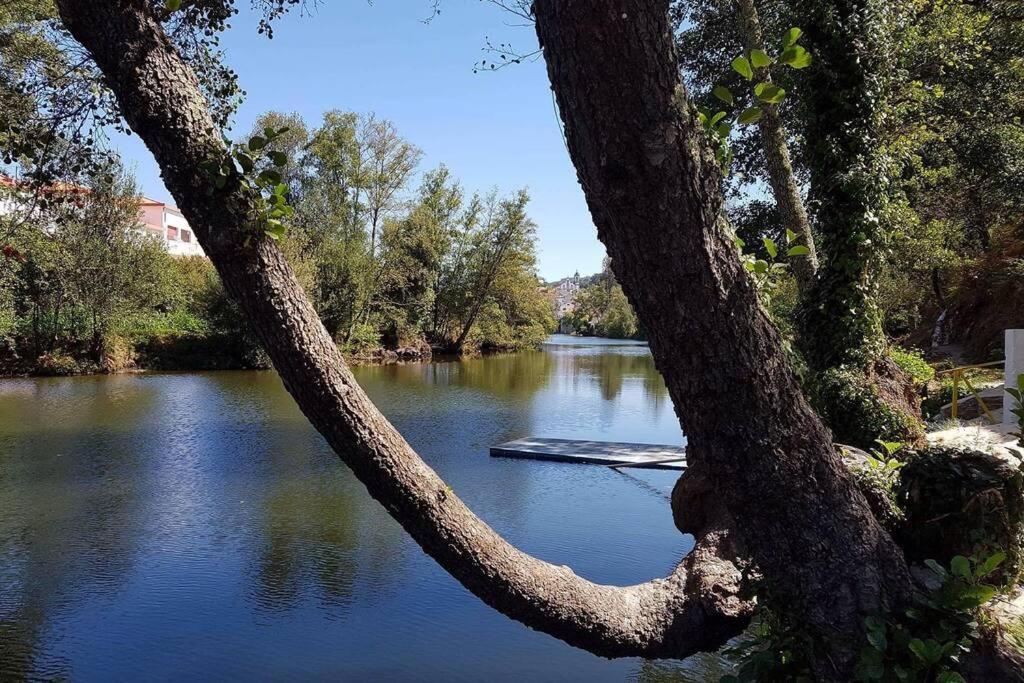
737, 0, 818, 295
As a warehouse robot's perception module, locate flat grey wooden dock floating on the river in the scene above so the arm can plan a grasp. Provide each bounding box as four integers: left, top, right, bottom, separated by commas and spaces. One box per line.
490, 436, 686, 470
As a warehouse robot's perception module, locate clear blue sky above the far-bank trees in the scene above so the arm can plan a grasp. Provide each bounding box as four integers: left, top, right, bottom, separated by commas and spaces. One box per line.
114, 0, 604, 280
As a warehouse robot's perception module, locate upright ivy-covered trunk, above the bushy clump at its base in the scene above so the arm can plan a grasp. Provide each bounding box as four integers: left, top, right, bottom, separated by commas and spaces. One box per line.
798, 0, 892, 371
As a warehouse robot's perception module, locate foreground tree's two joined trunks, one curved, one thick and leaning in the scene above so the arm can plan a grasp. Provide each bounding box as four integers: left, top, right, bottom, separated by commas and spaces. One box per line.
57, 0, 908, 679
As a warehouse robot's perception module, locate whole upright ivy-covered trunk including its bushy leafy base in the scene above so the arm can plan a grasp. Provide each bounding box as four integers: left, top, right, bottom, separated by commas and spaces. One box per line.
797, 0, 924, 447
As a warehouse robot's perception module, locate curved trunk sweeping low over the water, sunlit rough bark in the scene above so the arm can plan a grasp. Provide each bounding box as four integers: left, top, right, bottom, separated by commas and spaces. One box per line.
49, 0, 751, 657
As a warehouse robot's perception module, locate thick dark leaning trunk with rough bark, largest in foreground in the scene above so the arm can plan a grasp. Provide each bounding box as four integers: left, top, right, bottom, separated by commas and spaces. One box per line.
534, 0, 909, 679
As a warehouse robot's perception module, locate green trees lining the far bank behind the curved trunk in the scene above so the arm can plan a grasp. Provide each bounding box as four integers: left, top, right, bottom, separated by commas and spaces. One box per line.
0, 112, 555, 374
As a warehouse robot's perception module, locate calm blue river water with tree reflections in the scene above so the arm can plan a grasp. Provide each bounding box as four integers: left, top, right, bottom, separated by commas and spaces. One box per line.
0, 337, 729, 681
